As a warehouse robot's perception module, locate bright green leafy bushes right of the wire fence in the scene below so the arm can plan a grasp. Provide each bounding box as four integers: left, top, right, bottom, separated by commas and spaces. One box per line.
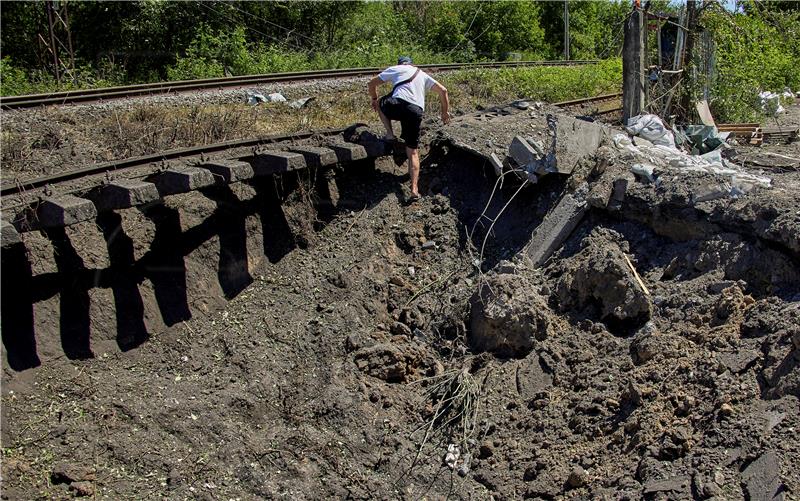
703, 8, 800, 122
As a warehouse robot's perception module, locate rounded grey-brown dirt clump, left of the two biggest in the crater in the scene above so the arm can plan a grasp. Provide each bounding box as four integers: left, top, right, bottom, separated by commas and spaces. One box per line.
469, 270, 558, 358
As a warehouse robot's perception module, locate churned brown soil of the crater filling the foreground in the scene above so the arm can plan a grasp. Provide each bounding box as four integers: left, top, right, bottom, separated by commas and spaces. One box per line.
2, 103, 800, 499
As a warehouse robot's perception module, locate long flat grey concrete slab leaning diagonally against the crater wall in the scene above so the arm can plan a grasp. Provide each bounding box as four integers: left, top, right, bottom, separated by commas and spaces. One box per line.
525, 188, 588, 266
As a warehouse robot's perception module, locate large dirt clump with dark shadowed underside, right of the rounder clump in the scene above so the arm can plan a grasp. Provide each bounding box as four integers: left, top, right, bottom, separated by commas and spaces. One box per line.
555, 229, 652, 328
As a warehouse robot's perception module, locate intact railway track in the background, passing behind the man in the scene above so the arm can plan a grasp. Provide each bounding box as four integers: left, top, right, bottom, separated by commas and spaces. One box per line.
0, 60, 598, 110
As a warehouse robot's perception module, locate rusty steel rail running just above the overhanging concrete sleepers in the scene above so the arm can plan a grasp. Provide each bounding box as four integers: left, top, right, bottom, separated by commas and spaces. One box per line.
0, 124, 352, 196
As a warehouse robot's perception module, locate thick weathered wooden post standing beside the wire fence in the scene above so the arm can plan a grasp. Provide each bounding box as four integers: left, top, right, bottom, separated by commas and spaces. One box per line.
622, 0, 645, 122
